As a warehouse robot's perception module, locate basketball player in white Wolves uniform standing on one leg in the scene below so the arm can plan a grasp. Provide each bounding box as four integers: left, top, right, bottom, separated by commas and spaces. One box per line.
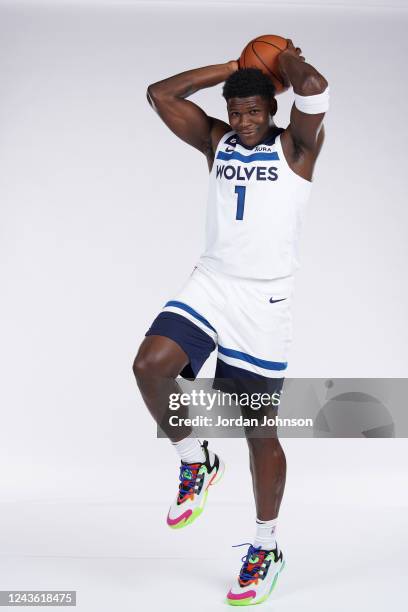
134, 41, 329, 605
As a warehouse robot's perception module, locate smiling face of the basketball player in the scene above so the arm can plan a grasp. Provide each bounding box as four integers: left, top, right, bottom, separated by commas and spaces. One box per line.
227, 96, 276, 147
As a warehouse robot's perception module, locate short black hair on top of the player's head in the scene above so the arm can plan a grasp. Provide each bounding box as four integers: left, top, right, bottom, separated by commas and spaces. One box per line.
222, 68, 276, 102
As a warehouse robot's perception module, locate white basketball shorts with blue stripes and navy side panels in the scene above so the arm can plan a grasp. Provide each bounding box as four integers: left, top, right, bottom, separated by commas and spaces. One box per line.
146, 262, 293, 390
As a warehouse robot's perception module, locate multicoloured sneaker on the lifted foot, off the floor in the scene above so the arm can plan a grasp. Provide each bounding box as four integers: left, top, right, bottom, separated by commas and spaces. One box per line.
167, 440, 225, 529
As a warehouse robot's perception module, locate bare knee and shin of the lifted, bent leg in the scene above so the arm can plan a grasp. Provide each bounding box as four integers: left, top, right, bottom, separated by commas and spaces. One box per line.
133, 336, 191, 442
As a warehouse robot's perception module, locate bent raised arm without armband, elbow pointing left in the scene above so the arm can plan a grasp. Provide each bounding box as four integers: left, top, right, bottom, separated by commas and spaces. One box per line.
147, 60, 238, 165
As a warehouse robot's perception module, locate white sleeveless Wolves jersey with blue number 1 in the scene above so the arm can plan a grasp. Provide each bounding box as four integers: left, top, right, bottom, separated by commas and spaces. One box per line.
197, 128, 312, 279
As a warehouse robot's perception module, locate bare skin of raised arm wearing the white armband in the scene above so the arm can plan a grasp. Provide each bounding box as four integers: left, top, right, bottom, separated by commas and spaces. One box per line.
279, 40, 328, 158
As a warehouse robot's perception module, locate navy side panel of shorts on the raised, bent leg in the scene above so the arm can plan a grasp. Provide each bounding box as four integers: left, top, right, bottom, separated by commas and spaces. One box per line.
145, 311, 215, 380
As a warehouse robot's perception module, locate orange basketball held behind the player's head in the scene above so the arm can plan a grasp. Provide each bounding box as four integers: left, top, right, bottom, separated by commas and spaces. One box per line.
238, 34, 288, 93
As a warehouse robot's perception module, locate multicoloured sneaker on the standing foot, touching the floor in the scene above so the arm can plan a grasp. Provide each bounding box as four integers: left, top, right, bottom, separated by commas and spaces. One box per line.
226, 544, 285, 606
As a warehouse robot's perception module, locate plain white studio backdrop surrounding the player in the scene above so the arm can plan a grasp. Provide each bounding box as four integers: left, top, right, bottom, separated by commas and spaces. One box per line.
0, 2, 408, 608
